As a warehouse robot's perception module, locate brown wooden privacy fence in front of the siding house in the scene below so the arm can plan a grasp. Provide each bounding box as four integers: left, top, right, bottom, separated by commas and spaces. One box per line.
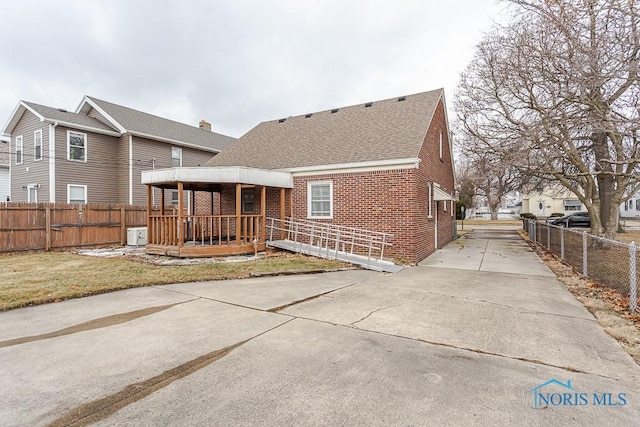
0, 202, 147, 252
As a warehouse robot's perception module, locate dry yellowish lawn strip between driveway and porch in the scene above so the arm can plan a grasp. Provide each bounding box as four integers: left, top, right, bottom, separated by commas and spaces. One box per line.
0, 252, 346, 310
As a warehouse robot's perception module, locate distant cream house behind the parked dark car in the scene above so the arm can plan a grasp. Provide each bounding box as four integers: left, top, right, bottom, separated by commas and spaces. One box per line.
522, 185, 586, 217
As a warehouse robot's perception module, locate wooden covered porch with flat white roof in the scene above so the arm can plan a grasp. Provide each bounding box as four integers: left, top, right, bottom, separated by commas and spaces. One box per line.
142, 166, 293, 257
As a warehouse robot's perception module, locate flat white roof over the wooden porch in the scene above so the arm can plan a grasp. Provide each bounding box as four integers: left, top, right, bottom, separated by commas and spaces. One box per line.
142, 166, 293, 188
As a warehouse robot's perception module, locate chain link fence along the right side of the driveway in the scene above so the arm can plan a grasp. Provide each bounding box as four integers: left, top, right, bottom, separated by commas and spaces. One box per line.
522, 219, 640, 313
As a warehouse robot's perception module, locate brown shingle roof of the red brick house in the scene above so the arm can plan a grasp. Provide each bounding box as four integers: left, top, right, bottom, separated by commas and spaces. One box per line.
206, 89, 443, 169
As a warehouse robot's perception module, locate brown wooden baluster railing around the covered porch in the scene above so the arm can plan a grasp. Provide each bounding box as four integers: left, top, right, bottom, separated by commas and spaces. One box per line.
147, 215, 263, 246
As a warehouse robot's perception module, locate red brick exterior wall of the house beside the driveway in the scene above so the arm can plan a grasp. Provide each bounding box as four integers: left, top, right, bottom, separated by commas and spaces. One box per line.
198, 98, 455, 263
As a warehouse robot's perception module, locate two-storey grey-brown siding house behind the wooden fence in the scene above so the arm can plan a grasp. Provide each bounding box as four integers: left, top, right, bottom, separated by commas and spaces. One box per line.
3, 96, 235, 205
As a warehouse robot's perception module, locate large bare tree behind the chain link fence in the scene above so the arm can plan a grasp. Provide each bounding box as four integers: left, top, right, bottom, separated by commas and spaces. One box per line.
455, 0, 640, 241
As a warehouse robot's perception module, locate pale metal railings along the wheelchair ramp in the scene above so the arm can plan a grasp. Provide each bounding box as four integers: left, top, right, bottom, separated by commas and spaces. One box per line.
267, 218, 393, 260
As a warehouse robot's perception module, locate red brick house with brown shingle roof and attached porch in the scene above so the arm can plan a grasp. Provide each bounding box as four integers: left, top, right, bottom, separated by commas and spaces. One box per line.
142, 89, 455, 263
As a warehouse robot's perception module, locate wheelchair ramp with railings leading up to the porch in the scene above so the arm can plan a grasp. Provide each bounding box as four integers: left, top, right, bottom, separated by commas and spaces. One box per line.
267, 218, 404, 273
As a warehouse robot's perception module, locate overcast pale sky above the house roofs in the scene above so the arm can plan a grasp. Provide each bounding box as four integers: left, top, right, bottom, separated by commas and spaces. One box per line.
0, 0, 510, 137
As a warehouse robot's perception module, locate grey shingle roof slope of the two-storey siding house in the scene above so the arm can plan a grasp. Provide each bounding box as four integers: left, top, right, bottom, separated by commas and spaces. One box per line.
87, 96, 236, 151
